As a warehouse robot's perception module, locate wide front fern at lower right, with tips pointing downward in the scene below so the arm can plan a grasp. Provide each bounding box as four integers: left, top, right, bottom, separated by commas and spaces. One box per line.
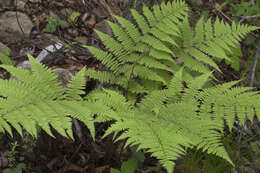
87, 70, 260, 172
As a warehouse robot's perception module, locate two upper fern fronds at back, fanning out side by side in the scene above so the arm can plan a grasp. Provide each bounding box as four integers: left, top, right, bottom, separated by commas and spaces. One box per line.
85, 0, 257, 96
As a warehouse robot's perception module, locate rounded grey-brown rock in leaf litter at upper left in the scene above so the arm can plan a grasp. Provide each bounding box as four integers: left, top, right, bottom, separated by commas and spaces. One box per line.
0, 11, 33, 43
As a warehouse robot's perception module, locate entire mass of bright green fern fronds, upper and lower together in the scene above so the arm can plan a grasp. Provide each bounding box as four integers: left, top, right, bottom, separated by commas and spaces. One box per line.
0, 0, 260, 172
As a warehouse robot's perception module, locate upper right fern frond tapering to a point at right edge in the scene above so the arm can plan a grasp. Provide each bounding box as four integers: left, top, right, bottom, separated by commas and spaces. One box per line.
173, 15, 258, 73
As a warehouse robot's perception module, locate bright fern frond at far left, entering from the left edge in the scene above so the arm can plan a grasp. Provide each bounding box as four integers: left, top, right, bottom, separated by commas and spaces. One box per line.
0, 55, 109, 138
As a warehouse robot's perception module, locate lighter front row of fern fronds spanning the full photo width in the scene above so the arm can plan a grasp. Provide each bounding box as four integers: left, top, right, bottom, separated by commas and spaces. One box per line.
0, 56, 260, 172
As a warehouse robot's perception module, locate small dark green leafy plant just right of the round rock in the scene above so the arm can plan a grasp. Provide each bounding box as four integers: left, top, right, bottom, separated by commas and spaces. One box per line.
42, 17, 69, 33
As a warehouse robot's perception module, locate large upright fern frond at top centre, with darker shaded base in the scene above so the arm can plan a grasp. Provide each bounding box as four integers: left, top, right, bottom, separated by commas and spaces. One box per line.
83, 1, 188, 97
